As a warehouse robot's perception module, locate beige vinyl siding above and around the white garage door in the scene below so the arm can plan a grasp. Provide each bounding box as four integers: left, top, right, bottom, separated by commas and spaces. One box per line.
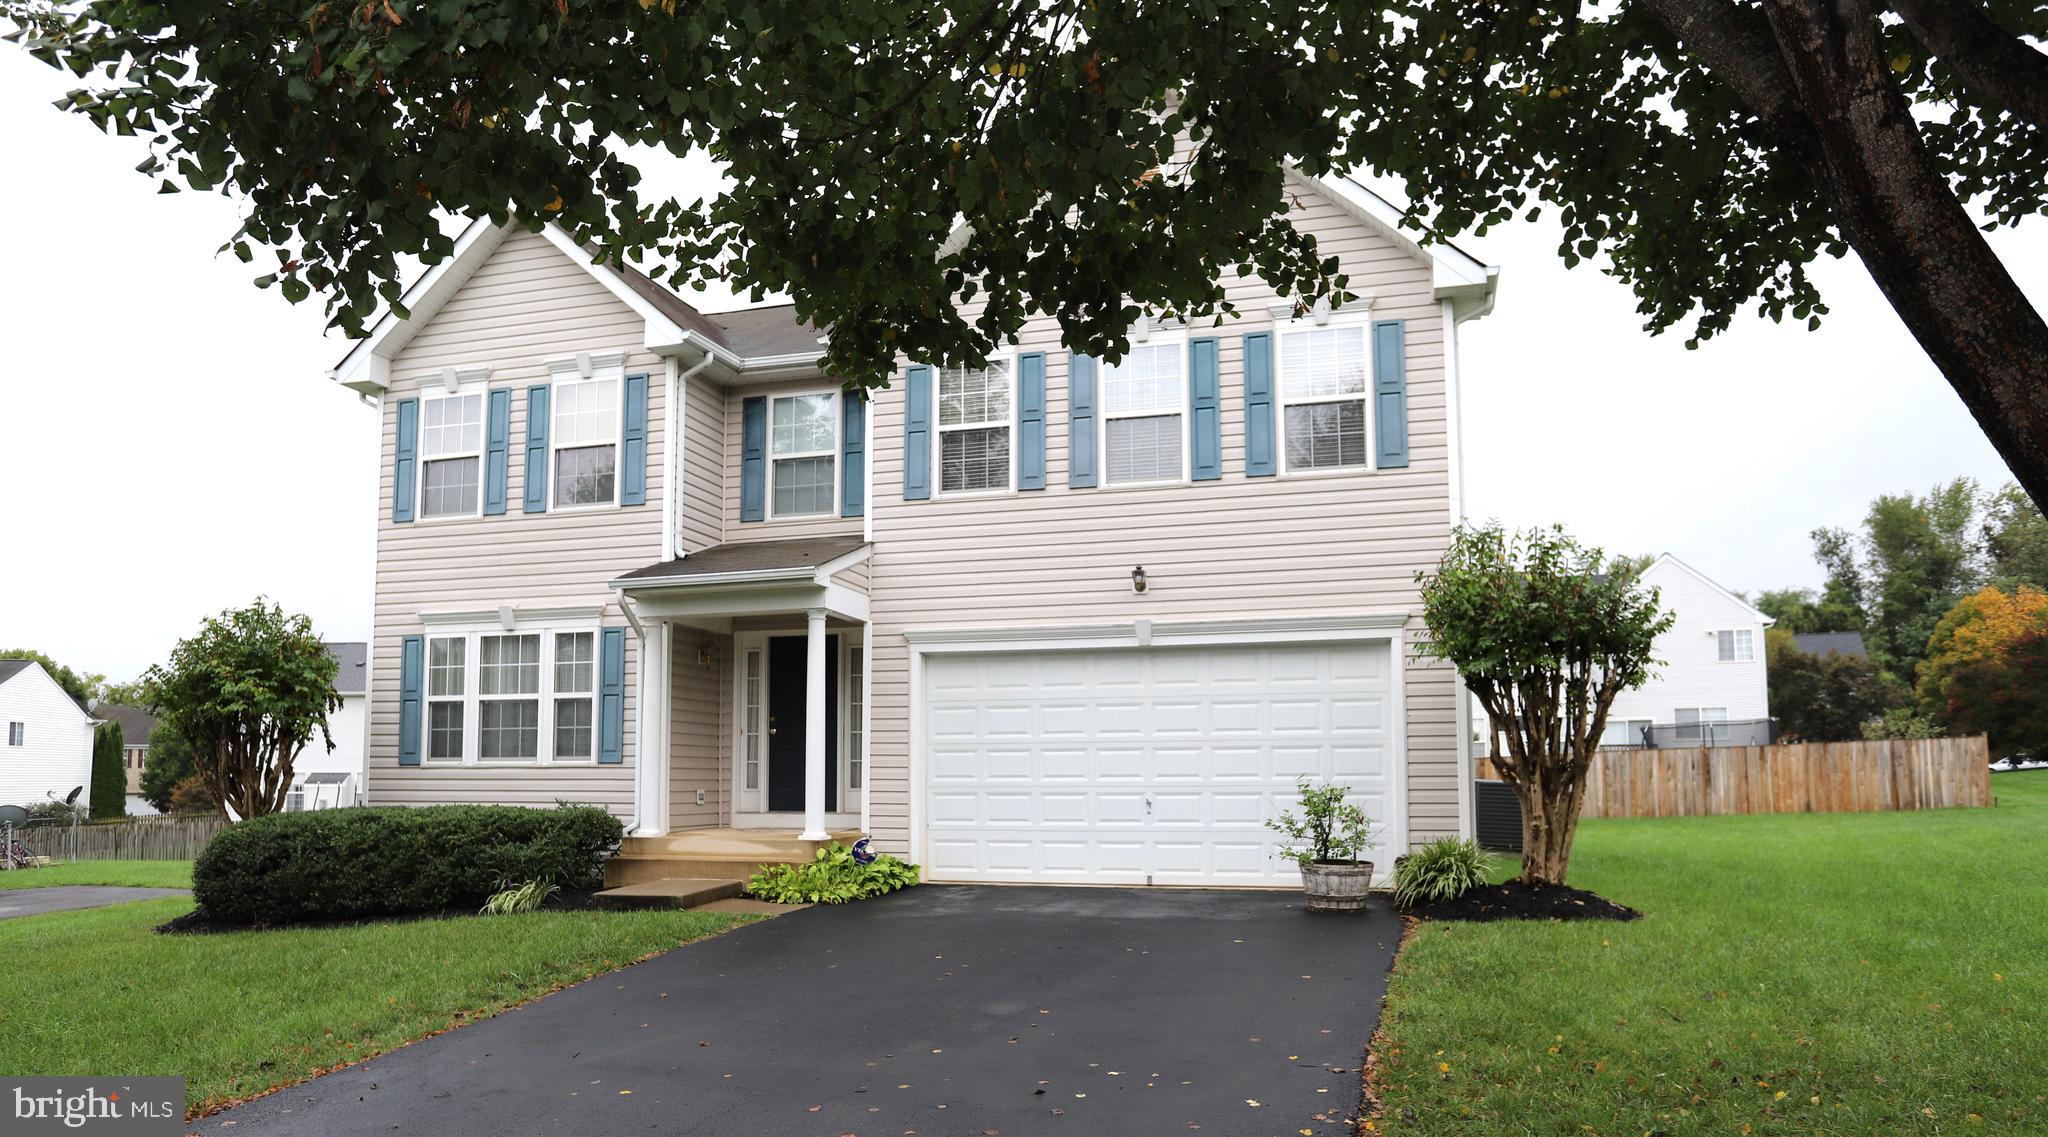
868, 180, 1458, 850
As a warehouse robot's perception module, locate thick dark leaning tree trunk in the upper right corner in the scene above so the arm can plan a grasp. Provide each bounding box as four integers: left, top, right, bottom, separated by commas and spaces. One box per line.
1763, 0, 2048, 504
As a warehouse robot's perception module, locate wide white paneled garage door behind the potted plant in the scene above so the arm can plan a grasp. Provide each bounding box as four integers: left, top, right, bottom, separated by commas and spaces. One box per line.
924, 643, 1399, 885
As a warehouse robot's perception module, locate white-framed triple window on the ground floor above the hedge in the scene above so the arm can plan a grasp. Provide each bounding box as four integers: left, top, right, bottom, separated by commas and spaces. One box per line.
424, 625, 598, 764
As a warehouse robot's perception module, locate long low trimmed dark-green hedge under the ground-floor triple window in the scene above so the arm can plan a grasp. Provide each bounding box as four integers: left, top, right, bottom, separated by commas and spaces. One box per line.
193, 805, 625, 926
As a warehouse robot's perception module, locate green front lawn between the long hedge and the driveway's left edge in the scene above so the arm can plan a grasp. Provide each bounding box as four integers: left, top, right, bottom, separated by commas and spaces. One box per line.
0, 881, 745, 1112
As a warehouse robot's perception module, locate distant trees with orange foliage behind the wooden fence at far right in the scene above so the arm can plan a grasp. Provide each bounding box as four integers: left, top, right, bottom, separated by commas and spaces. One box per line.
1755, 477, 2048, 756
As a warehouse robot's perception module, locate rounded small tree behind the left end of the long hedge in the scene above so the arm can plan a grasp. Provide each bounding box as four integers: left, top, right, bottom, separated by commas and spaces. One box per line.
141, 598, 342, 817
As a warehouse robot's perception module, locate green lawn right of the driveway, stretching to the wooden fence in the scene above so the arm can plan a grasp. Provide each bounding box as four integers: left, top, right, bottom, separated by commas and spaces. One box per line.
1378, 772, 2048, 1137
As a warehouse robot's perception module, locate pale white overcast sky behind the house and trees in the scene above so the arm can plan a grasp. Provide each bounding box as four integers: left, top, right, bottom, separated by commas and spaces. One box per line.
0, 49, 2048, 680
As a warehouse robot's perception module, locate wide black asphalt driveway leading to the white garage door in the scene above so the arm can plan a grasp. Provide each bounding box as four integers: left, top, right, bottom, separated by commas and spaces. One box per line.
188, 885, 1401, 1137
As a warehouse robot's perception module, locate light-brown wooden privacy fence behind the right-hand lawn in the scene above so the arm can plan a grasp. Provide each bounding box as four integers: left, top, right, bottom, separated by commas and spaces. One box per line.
1475, 735, 1991, 817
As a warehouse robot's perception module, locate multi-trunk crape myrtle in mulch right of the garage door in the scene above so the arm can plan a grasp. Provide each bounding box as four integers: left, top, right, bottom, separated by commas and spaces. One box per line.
1415, 524, 1673, 885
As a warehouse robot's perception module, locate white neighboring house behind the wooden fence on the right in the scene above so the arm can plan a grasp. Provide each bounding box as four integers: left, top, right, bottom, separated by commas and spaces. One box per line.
1602, 553, 1774, 746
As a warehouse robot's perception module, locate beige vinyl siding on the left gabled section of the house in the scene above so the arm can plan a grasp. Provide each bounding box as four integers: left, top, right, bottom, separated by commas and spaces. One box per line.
367, 234, 668, 817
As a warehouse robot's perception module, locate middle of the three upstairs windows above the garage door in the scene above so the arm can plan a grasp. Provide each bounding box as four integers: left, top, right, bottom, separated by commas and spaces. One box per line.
1102, 336, 1188, 486
